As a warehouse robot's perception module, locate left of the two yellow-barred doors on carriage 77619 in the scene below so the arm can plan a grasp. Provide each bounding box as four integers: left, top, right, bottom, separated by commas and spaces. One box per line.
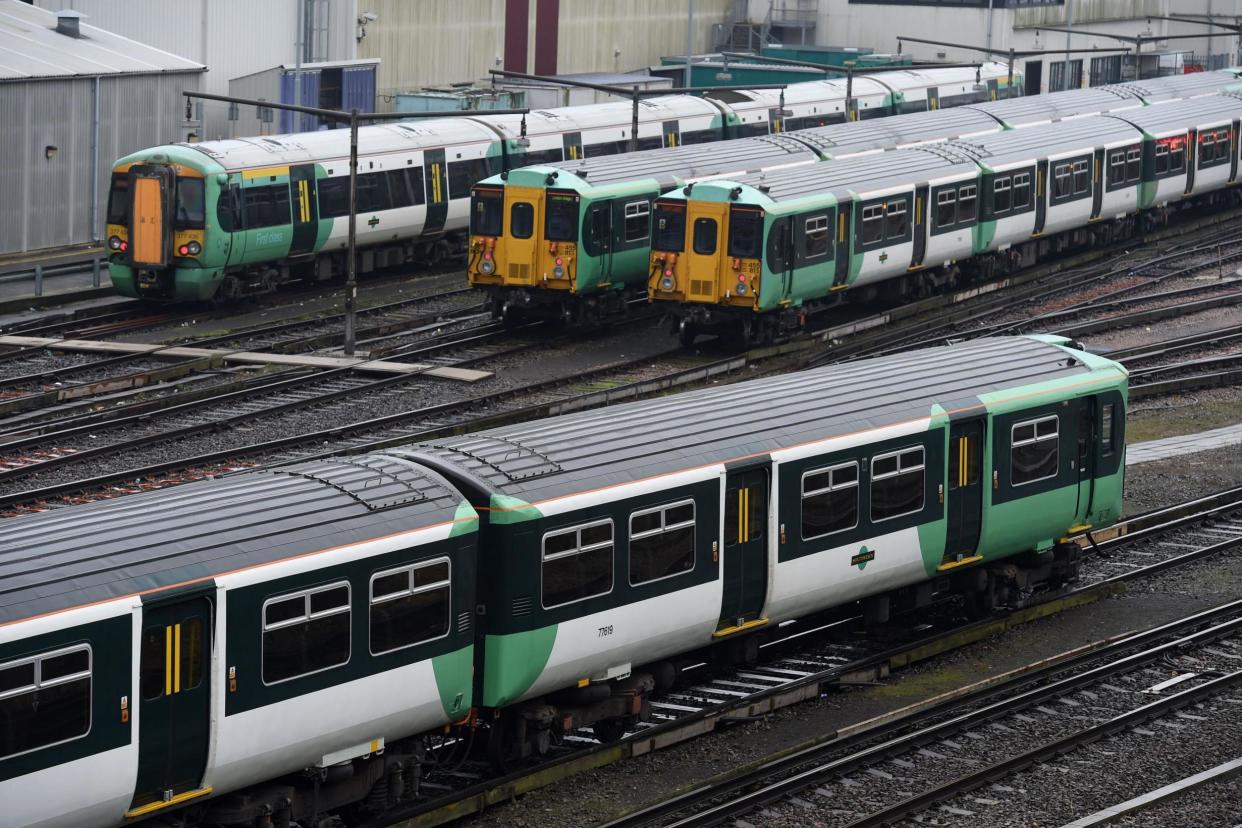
717, 459, 771, 634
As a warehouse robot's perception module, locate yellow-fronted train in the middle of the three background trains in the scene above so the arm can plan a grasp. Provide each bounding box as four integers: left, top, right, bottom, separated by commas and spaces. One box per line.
467, 71, 1240, 330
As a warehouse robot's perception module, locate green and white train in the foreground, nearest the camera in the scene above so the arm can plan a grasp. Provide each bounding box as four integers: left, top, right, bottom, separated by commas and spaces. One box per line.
0, 335, 1128, 828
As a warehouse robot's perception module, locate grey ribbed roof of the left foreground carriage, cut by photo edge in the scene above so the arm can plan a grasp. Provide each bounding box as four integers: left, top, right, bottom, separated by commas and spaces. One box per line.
0, 454, 462, 624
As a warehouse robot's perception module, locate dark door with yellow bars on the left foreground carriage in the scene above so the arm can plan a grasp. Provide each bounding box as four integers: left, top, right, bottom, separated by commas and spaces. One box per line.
125, 593, 212, 818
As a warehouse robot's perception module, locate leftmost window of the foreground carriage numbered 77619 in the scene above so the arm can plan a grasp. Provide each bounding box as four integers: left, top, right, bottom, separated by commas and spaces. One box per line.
542, 520, 612, 608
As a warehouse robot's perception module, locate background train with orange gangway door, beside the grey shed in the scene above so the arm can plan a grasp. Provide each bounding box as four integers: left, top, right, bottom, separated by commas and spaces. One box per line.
106, 63, 1021, 302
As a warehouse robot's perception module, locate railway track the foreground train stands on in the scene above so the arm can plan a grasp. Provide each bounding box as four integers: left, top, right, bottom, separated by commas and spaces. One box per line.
368, 487, 1242, 828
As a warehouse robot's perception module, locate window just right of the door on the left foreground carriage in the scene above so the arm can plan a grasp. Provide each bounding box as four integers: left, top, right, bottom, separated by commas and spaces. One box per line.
263, 582, 350, 684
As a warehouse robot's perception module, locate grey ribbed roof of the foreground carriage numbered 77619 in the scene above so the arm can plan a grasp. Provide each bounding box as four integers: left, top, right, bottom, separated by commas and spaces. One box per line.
412, 336, 1124, 506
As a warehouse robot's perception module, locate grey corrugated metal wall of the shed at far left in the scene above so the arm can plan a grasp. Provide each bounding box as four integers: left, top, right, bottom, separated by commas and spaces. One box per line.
0, 73, 201, 253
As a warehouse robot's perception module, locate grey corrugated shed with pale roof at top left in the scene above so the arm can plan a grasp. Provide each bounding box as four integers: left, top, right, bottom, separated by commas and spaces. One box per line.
0, 0, 205, 253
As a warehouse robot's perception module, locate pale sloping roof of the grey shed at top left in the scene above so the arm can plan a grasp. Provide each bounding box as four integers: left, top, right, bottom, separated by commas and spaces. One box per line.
0, 0, 206, 82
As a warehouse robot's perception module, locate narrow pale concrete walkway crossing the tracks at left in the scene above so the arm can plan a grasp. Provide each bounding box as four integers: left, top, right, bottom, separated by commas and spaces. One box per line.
0, 335, 492, 382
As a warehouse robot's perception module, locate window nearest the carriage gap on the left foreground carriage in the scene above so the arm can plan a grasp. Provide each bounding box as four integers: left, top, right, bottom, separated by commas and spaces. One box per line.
370, 557, 451, 655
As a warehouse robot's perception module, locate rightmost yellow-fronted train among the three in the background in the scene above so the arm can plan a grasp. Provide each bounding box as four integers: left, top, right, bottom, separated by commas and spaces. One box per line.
648, 92, 1242, 344
